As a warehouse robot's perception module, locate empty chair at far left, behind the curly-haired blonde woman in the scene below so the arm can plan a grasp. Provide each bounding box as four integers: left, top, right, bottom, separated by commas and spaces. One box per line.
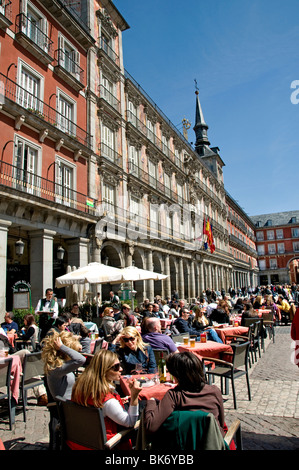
20, 352, 44, 421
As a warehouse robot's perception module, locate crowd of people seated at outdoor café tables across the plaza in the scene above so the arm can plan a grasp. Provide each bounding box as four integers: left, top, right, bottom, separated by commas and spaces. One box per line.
0, 285, 299, 448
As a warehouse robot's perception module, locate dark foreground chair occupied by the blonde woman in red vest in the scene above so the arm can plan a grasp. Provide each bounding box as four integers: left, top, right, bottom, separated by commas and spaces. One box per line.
56, 396, 139, 450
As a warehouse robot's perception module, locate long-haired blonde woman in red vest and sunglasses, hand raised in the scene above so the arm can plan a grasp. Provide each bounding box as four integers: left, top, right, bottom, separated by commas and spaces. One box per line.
72, 349, 141, 450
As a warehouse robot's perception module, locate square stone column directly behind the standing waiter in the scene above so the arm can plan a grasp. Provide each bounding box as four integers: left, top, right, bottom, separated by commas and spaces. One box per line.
30, 230, 56, 308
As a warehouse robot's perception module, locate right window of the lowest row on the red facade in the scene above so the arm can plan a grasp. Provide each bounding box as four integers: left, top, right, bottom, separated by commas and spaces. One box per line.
56, 158, 76, 206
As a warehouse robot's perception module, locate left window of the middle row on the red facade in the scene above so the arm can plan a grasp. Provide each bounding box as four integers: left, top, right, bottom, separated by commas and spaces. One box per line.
17, 61, 43, 113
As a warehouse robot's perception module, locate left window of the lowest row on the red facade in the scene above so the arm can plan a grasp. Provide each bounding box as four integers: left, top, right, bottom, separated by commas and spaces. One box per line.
14, 137, 40, 194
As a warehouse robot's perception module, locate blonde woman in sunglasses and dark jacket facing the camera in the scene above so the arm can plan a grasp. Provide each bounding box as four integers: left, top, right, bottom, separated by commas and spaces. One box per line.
110, 326, 157, 374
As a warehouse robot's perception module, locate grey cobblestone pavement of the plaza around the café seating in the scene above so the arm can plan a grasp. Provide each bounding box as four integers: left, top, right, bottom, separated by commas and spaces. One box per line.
0, 326, 299, 450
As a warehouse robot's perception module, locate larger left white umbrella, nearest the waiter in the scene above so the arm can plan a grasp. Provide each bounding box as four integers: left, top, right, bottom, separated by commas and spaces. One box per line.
55, 263, 122, 287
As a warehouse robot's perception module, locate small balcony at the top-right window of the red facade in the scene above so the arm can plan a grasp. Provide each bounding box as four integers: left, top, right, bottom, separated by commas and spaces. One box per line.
54, 49, 84, 92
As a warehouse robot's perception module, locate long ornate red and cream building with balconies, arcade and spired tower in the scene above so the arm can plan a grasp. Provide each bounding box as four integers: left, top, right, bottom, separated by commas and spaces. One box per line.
0, 0, 256, 318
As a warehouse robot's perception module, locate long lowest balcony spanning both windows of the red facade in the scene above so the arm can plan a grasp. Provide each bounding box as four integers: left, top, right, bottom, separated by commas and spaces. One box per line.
0, 162, 96, 215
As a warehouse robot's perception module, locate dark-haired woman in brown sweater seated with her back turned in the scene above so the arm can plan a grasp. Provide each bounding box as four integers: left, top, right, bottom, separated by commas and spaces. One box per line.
144, 352, 225, 435
